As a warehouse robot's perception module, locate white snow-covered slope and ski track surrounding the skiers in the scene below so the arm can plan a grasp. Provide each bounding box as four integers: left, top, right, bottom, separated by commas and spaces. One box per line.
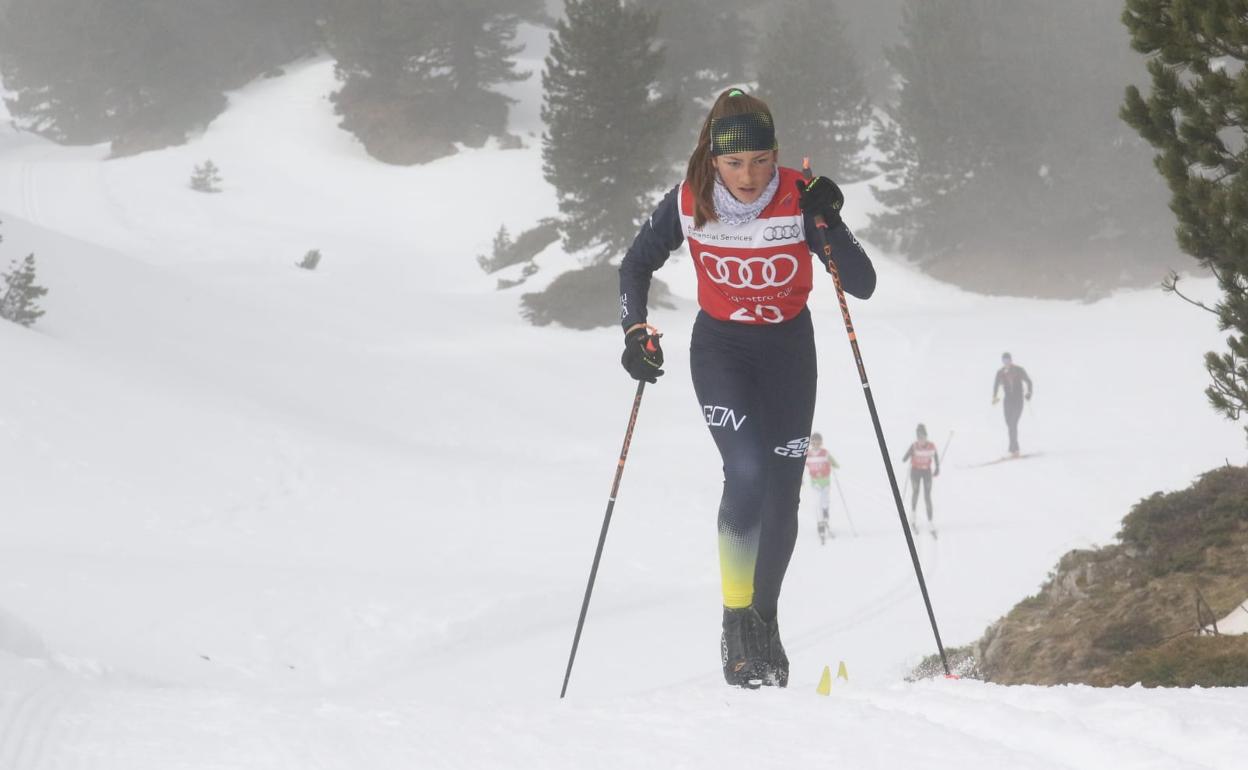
0, 30, 1248, 770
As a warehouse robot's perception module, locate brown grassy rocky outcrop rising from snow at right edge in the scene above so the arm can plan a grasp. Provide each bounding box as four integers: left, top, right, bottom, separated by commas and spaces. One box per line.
918, 467, 1248, 686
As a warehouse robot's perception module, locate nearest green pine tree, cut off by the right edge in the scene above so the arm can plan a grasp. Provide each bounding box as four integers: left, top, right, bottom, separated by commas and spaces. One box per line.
1122, 0, 1248, 434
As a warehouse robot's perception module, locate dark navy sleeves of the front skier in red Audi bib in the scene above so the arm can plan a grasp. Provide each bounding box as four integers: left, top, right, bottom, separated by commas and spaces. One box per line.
619, 178, 876, 329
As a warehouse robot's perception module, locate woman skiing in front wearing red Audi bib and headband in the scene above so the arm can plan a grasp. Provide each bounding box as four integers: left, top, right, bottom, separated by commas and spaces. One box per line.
619, 89, 875, 688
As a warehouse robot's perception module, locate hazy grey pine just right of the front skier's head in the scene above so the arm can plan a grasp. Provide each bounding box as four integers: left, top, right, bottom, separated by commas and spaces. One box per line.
759, 0, 871, 182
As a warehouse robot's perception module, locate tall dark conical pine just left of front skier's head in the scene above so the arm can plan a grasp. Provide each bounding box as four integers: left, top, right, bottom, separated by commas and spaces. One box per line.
542, 0, 678, 262
